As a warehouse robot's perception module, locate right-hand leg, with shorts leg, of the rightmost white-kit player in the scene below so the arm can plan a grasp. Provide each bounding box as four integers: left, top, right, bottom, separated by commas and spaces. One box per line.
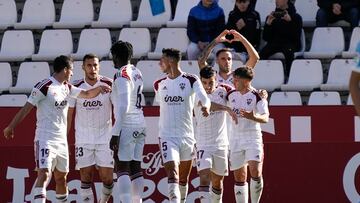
246, 146, 264, 203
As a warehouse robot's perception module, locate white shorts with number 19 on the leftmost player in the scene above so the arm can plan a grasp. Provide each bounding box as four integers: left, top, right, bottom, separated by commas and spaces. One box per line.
34, 140, 69, 173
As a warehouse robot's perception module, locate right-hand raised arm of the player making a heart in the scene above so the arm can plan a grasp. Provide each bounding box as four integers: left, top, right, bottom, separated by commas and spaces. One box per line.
230, 30, 260, 68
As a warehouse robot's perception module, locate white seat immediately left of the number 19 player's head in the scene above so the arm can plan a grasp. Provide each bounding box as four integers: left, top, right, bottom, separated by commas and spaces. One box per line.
9, 62, 50, 94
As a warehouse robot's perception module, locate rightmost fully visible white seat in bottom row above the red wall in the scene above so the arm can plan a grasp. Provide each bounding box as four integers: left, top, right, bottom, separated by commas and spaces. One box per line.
308, 91, 341, 106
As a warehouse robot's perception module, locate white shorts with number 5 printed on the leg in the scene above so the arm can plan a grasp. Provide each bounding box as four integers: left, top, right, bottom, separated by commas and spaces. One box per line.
159, 137, 195, 164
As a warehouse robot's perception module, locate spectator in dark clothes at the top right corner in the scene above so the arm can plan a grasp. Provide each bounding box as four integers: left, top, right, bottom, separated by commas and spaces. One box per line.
316, 0, 359, 28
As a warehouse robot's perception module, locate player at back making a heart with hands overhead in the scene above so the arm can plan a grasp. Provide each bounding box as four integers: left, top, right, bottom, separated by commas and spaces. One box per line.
198, 30, 259, 86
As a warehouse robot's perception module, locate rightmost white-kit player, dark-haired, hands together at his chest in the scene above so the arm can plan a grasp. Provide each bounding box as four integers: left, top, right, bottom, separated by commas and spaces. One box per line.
227, 67, 269, 203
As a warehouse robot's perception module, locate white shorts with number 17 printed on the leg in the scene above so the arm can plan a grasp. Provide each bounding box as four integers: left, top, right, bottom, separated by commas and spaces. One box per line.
196, 148, 229, 176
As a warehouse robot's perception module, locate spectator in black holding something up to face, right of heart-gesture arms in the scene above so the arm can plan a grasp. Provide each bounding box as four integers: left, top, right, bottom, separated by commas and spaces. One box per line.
260, 0, 302, 76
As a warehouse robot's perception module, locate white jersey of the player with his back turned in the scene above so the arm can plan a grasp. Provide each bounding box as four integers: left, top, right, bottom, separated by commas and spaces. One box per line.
111, 64, 146, 135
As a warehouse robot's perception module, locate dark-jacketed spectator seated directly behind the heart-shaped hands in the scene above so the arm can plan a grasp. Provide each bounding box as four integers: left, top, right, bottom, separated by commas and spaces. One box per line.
225, 0, 261, 62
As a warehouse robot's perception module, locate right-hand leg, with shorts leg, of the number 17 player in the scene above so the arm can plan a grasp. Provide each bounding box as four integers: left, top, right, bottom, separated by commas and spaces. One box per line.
211, 149, 229, 203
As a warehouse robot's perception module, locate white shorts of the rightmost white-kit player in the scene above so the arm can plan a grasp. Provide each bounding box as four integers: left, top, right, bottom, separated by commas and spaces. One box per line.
229, 142, 264, 171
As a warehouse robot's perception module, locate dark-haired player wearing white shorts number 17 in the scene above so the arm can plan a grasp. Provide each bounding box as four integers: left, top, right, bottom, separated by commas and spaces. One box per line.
194, 66, 237, 203
